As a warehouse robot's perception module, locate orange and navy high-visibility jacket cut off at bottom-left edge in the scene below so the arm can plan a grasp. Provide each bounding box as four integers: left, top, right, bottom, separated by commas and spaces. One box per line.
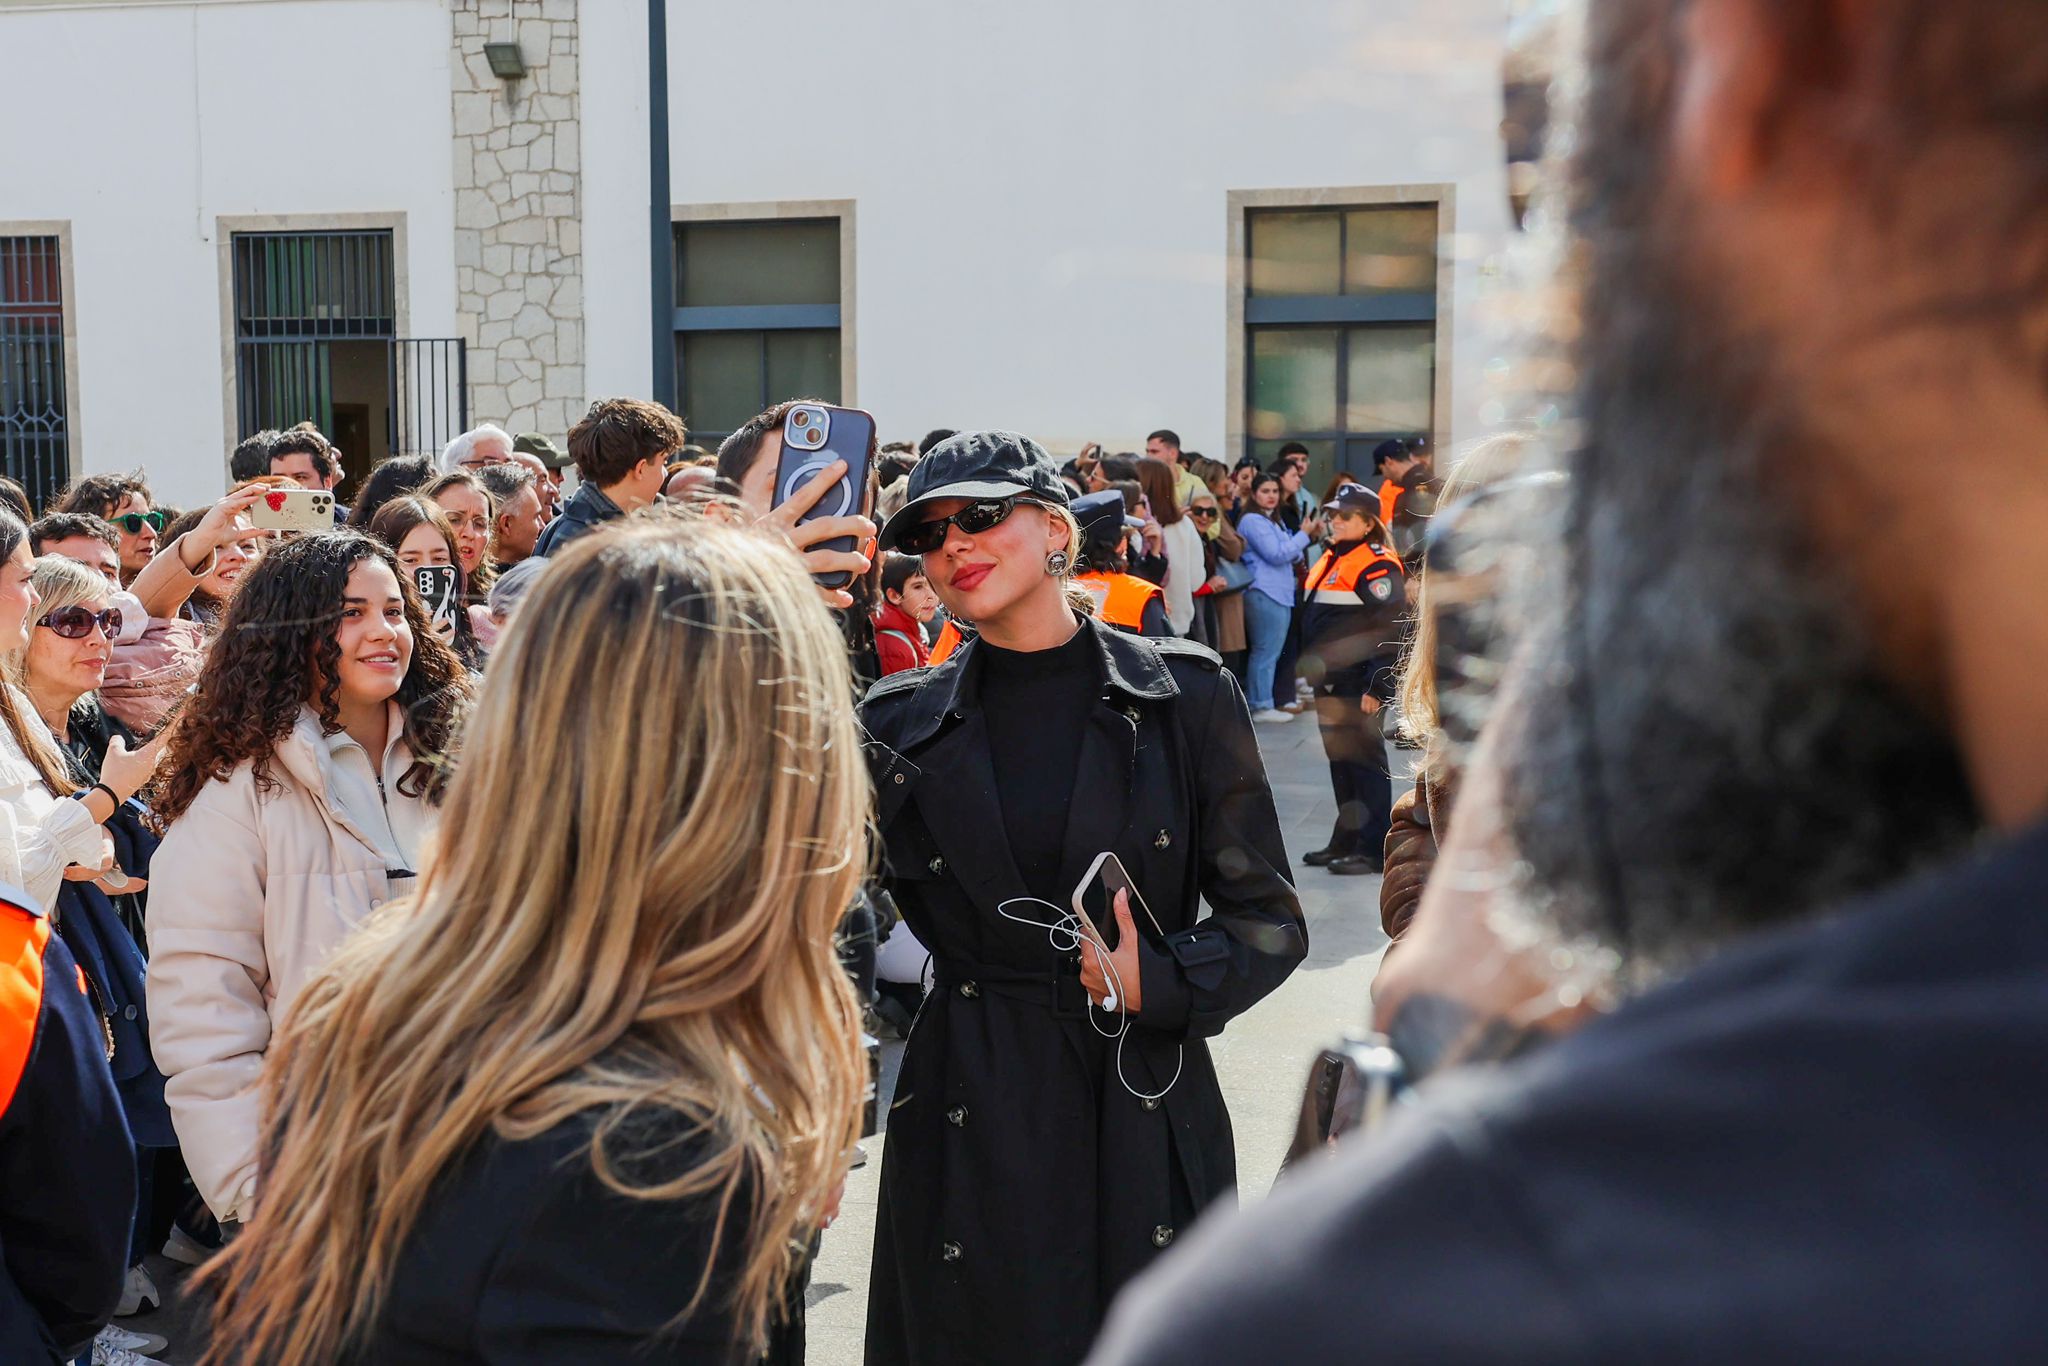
0, 889, 135, 1362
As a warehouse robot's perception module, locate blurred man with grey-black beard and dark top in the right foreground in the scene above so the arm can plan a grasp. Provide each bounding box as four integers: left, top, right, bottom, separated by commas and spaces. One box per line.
1094, 0, 2048, 1366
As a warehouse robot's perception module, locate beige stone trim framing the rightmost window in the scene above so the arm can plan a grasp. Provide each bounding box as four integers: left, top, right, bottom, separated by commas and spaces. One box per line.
1223, 184, 1458, 463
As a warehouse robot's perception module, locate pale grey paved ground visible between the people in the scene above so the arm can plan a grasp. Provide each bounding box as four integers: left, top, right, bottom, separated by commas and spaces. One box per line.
125, 713, 1405, 1366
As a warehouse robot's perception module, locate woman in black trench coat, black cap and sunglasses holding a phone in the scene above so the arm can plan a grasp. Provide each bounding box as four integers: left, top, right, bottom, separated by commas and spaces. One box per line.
862, 432, 1307, 1366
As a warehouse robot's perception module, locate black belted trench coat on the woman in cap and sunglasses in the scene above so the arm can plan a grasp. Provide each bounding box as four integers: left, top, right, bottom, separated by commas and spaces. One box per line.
862, 621, 1307, 1366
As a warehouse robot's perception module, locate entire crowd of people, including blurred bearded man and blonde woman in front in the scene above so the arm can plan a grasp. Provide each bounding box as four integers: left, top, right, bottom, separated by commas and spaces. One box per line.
0, 0, 2048, 1366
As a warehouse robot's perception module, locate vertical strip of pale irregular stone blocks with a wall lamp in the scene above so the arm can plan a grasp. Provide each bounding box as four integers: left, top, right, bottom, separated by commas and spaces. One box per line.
449, 0, 586, 442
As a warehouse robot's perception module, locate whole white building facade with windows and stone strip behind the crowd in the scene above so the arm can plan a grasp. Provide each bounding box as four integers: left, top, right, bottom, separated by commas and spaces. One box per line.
0, 0, 1507, 504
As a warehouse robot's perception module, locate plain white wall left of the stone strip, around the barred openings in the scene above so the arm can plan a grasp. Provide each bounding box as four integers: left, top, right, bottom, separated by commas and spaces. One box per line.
0, 0, 455, 504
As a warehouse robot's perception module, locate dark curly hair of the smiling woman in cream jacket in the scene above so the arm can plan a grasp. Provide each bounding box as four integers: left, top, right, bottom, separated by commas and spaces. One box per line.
150, 530, 471, 829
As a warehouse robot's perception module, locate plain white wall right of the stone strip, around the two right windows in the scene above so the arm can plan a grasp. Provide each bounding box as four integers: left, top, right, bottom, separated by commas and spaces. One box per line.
584, 0, 1505, 455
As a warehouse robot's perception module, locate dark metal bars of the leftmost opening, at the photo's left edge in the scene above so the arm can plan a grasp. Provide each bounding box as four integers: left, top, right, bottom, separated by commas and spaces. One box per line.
0, 238, 72, 508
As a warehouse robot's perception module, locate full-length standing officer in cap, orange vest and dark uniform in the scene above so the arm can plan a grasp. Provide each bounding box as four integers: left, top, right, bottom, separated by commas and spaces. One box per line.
1300, 485, 1407, 874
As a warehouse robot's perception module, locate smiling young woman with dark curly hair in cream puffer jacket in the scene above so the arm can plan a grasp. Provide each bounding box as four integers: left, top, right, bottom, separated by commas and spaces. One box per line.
150, 530, 469, 1223
